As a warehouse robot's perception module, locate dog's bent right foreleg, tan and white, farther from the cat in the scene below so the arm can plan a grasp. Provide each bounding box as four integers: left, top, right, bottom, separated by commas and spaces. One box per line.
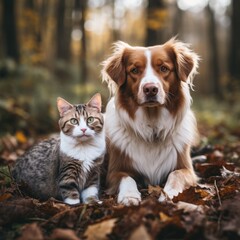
158, 169, 197, 202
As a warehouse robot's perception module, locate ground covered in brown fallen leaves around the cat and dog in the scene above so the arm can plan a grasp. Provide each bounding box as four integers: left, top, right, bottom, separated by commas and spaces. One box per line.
0, 132, 240, 240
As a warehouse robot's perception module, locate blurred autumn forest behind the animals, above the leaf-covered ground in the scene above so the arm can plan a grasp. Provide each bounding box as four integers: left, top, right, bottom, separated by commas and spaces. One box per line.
0, 0, 240, 142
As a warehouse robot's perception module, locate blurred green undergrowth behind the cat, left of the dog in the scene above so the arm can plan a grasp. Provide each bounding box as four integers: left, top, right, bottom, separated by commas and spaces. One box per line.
0, 62, 106, 135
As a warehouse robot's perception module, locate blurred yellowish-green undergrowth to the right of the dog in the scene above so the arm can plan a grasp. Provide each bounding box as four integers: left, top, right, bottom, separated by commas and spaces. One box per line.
193, 95, 240, 143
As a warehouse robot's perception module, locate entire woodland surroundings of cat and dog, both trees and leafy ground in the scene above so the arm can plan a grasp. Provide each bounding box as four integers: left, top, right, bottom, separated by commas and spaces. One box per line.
0, 0, 240, 240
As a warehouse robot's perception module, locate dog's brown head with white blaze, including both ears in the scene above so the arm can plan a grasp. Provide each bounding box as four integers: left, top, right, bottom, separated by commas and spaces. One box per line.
102, 38, 199, 115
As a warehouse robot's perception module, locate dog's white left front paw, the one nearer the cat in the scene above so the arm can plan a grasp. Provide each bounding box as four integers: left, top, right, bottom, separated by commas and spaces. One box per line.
117, 177, 141, 206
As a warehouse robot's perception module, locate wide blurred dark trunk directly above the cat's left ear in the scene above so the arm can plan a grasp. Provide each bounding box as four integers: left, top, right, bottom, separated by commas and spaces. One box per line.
56, 0, 72, 60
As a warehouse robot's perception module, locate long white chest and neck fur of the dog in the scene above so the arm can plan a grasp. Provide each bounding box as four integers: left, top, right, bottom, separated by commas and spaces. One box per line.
105, 96, 195, 184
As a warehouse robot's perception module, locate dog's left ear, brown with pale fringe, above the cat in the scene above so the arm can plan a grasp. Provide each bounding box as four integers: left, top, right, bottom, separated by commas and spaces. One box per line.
102, 41, 130, 87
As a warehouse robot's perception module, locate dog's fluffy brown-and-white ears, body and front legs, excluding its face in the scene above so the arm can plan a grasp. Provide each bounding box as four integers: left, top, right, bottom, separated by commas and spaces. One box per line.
102, 38, 199, 205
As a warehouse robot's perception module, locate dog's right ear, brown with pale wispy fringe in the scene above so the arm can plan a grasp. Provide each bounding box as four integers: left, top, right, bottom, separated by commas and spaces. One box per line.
164, 38, 200, 84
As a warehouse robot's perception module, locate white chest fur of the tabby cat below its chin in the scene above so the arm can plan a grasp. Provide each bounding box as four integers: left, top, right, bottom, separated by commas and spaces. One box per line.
60, 131, 106, 171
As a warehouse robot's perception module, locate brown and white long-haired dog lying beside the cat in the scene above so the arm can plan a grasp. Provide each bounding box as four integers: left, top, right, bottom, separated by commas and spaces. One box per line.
102, 38, 199, 205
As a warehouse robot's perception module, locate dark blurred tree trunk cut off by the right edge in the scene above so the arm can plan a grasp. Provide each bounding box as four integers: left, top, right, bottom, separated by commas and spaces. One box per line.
229, 0, 240, 80
